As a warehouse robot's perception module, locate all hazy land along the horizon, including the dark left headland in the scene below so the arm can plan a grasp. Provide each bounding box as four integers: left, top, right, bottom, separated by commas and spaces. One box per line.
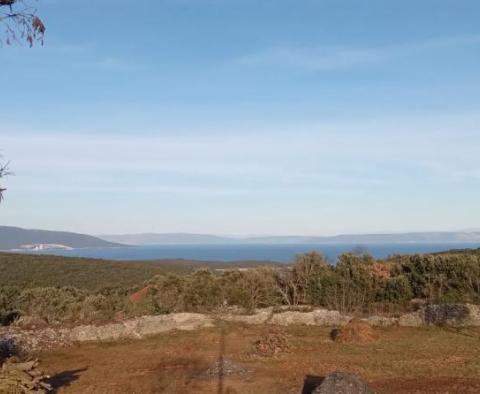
4, 226, 480, 251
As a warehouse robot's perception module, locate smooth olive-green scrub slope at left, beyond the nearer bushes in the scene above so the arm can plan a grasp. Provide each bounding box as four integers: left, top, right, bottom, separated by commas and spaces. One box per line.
0, 253, 274, 291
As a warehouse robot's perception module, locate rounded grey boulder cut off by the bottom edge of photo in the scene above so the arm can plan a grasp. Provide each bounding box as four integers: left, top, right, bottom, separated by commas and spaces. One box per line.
312, 372, 375, 394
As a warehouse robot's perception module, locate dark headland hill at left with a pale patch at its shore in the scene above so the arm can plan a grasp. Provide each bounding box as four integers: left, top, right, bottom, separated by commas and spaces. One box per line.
0, 226, 121, 250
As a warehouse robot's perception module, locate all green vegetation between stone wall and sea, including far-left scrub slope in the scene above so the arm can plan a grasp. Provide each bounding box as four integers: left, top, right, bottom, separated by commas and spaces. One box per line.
0, 251, 480, 324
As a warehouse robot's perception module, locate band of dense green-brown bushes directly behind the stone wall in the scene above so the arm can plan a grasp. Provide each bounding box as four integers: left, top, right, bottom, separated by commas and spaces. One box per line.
0, 252, 480, 324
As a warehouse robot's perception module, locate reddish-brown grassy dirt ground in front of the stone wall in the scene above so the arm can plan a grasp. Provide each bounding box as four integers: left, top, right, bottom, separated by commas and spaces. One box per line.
39, 324, 480, 394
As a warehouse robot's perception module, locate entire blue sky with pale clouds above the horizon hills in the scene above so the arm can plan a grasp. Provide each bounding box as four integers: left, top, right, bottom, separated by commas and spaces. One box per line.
0, 0, 480, 235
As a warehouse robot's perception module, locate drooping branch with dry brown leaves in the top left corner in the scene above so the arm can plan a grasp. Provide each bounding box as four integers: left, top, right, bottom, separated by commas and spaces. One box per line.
0, 0, 45, 47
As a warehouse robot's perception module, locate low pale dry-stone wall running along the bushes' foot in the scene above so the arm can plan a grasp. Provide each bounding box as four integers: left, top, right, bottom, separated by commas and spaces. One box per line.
0, 304, 480, 351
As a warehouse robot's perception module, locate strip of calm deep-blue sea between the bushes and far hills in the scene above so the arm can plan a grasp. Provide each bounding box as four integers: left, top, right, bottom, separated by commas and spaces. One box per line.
28, 243, 480, 262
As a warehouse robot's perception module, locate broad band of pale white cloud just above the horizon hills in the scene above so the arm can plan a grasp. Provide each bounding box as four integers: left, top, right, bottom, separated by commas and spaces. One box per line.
0, 114, 480, 234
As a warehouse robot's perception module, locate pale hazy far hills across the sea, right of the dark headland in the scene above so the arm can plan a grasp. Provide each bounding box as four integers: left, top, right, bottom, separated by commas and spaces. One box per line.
99, 232, 480, 245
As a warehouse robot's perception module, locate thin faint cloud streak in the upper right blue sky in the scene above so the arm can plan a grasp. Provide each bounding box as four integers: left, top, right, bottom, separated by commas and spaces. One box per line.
237, 34, 480, 71
